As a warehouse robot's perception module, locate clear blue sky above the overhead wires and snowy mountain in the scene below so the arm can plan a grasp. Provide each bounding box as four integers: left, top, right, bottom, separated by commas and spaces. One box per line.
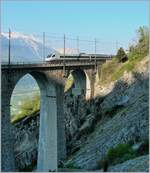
1, 0, 149, 52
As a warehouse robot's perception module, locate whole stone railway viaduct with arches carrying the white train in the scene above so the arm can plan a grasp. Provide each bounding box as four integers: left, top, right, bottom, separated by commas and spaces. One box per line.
1, 56, 111, 172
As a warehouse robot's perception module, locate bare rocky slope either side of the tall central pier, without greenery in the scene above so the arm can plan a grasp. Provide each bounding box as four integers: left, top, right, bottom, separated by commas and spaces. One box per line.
12, 57, 149, 171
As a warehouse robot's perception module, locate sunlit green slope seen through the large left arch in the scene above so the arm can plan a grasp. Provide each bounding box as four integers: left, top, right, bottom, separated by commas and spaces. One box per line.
11, 94, 40, 123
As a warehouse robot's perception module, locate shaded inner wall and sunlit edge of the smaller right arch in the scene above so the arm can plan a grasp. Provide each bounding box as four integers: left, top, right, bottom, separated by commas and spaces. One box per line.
71, 69, 91, 99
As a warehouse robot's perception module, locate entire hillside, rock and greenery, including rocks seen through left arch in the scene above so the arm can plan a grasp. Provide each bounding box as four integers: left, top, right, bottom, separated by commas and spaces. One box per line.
10, 26, 149, 172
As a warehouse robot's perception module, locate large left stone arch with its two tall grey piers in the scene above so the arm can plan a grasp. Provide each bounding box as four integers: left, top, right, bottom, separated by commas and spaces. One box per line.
2, 71, 65, 172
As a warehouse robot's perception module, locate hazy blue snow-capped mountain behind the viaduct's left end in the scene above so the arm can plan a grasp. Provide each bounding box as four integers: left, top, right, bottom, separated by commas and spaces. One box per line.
1, 32, 55, 62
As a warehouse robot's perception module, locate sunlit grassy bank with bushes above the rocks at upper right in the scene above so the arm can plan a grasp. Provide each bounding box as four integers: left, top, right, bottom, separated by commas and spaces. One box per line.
98, 26, 149, 84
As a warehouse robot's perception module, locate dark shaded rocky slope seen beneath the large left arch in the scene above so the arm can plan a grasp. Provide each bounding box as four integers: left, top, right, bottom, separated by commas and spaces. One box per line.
14, 113, 39, 171
